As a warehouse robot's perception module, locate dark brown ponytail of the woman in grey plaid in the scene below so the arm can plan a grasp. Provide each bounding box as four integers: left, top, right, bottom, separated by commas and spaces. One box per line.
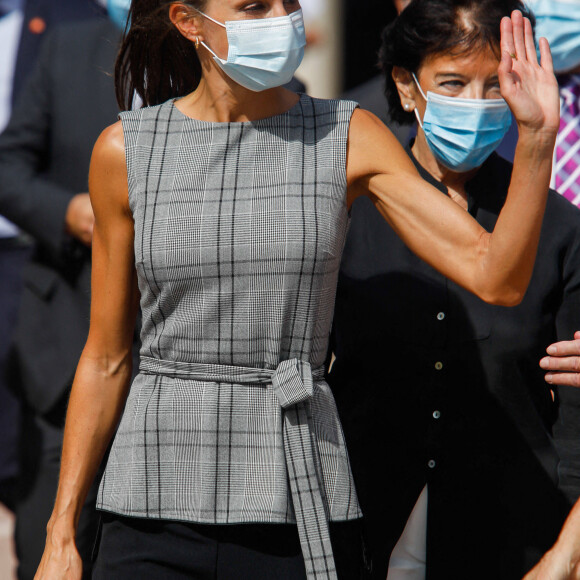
115, 0, 206, 109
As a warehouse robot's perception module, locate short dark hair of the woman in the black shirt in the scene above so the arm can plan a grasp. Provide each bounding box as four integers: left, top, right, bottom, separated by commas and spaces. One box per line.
379, 0, 535, 125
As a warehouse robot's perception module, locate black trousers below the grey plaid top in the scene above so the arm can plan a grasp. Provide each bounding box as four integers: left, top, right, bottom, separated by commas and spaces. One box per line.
93, 514, 366, 580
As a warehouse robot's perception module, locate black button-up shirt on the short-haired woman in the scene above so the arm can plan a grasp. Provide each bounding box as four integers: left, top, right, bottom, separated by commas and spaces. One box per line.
329, 151, 580, 580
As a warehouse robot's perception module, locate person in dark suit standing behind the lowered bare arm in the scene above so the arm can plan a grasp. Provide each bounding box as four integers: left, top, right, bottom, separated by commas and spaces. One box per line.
0, 2, 126, 580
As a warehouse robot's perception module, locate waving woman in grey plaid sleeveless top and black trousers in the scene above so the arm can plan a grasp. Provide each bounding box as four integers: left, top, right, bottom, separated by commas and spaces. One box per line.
37, 0, 559, 580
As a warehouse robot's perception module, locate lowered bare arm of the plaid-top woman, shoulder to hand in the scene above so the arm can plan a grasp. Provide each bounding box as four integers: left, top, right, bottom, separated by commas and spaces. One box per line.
36, 123, 138, 580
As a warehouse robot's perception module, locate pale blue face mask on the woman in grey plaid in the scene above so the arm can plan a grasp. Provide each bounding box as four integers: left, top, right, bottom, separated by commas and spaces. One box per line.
200, 10, 306, 91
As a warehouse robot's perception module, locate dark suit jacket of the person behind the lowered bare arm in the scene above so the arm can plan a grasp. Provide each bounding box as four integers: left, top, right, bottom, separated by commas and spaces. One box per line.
0, 20, 120, 412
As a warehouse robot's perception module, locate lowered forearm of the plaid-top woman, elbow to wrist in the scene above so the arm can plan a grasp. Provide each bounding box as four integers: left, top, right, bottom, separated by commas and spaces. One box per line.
49, 349, 131, 540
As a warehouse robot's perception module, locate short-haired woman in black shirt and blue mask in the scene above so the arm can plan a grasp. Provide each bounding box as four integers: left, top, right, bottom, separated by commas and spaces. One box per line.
329, 0, 580, 580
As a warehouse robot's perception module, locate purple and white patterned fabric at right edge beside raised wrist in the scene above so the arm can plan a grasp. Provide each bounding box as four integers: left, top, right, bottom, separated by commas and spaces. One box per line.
551, 75, 580, 206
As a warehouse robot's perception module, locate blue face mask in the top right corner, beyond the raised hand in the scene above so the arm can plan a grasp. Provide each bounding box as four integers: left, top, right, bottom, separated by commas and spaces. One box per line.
527, 0, 580, 72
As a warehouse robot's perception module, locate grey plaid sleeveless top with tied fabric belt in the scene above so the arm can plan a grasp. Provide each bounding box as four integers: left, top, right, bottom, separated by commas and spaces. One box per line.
98, 95, 361, 578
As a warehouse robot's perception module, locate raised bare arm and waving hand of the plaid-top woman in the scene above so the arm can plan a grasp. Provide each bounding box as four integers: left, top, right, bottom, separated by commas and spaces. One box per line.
347, 12, 559, 305
